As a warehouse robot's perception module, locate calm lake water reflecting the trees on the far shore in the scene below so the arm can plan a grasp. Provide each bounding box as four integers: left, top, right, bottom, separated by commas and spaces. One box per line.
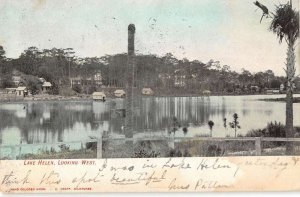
0, 95, 300, 145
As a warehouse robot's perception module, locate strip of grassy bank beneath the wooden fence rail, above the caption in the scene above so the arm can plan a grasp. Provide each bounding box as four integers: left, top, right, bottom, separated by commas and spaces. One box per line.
9, 140, 300, 160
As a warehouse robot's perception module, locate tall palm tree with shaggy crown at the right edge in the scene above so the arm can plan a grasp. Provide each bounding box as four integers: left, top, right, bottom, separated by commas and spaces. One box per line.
255, 1, 299, 155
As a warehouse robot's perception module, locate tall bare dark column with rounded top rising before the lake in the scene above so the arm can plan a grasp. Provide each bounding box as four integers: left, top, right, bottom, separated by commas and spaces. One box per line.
125, 24, 135, 138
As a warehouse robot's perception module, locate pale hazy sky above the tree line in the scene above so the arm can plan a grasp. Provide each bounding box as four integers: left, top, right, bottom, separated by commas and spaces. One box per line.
0, 0, 300, 75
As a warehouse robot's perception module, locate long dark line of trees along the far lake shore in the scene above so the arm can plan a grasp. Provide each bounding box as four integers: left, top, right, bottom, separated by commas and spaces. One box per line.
0, 46, 299, 94
